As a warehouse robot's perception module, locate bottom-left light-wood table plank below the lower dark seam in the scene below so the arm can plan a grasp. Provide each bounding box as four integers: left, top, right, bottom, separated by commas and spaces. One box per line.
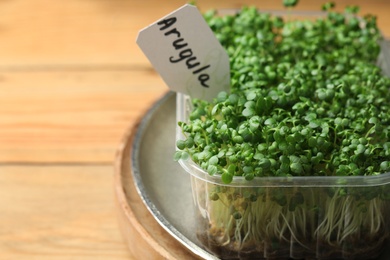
0, 166, 130, 260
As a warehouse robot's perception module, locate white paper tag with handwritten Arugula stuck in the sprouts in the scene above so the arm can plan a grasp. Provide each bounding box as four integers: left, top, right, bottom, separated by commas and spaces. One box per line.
137, 4, 230, 101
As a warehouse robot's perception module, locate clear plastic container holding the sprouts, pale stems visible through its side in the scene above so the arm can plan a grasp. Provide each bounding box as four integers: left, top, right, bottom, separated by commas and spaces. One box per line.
176, 9, 390, 260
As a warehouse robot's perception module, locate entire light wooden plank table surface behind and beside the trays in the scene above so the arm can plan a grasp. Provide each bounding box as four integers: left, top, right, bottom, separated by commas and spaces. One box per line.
0, 0, 390, 260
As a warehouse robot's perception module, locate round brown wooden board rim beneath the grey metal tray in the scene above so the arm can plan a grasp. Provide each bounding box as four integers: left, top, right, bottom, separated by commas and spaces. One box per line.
115, 93, 201, 259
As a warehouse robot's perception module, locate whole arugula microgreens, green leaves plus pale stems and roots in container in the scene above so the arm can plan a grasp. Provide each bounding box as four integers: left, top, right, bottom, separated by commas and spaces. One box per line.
174, 0, 390, 259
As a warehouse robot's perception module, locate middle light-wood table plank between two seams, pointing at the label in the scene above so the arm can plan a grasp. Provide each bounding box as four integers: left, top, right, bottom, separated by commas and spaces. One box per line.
0, 70, 168, 163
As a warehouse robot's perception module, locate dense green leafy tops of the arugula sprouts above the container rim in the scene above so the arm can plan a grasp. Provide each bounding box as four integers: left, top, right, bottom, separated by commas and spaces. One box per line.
175, 3, 390, 183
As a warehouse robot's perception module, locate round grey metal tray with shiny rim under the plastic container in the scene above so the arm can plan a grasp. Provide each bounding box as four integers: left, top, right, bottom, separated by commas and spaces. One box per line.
131, 93, 390, 260
